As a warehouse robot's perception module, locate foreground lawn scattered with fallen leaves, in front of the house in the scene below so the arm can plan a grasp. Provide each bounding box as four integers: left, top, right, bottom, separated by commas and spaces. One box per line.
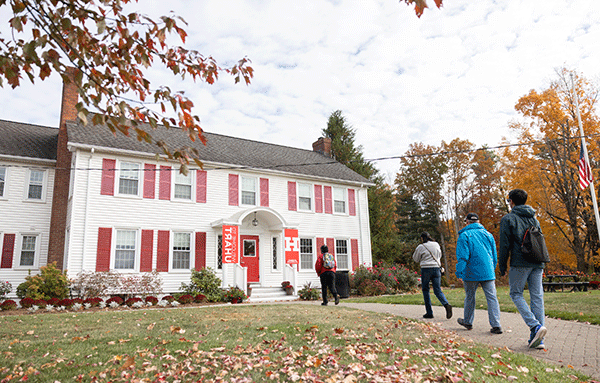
0, 304, 587, 382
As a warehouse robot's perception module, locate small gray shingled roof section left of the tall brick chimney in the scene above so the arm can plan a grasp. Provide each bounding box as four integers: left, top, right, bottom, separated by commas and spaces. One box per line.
0, 120, 58, 160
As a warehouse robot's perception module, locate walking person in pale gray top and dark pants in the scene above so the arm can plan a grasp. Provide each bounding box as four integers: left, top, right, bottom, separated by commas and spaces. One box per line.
413, 231, 452, 319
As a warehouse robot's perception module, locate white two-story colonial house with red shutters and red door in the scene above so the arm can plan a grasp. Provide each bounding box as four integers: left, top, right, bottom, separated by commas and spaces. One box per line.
0, 76, 372, 304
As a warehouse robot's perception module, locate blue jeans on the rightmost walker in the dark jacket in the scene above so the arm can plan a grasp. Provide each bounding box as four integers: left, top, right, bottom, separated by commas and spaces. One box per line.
508, 267, 545, 329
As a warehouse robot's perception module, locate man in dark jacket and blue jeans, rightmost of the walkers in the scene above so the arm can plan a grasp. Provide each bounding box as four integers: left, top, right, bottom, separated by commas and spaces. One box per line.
499, 189, 547, 348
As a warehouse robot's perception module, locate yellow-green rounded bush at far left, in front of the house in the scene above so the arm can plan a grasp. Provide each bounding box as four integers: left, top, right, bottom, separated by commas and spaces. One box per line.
17, 263, 69, 300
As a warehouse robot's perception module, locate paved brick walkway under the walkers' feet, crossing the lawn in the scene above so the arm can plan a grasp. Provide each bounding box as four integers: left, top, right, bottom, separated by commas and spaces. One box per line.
332, 300, 600, 380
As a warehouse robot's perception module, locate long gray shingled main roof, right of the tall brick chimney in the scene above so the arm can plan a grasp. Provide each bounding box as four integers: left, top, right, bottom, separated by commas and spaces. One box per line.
67, 122, 371, 184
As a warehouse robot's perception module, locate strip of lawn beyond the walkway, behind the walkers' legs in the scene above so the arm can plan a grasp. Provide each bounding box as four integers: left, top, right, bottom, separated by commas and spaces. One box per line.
351, 286, 600, 324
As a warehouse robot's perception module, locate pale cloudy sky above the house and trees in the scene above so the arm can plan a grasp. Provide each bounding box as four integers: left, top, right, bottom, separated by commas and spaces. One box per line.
0, 0, 600, 180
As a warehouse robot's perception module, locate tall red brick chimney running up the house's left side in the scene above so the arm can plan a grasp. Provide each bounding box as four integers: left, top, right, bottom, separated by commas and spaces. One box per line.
48, 68, 78, 270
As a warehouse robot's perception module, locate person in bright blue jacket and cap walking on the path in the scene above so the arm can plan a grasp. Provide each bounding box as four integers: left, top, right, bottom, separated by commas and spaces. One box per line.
456, 213, 502, 334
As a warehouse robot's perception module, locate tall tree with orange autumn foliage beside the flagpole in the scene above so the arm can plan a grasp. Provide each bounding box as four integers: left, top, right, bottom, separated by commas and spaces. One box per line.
503, 68, 600, 271
